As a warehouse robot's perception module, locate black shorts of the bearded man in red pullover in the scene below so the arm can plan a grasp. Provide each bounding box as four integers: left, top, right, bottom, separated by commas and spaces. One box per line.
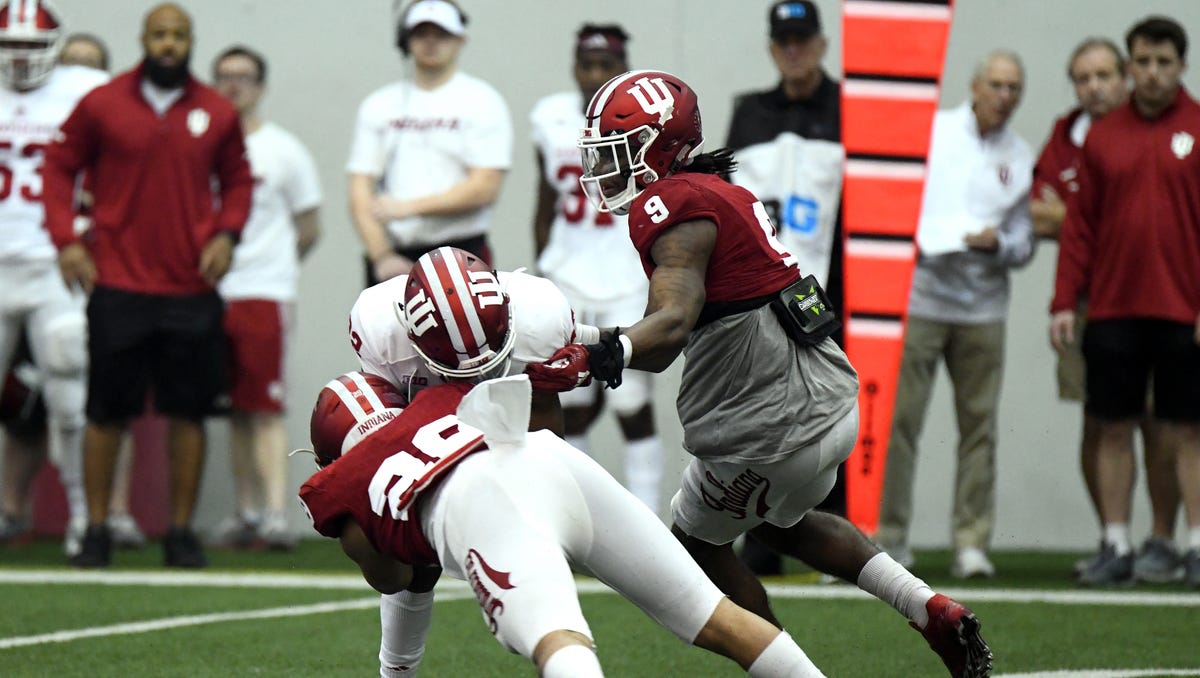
88, 288, 228, 424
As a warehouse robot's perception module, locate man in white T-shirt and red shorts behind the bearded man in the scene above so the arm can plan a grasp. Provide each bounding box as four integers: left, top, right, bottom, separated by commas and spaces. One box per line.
212, 46, 322, 550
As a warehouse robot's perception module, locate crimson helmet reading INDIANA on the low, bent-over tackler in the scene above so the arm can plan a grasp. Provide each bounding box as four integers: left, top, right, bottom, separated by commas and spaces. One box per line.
308, 372, 406, 468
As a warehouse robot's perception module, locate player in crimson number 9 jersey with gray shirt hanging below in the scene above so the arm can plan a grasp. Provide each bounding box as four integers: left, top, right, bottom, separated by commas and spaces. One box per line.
527, 71, 991, 677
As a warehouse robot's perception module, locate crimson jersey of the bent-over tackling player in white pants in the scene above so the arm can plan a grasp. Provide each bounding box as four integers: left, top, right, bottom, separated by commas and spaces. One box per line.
300, 382, 486, 565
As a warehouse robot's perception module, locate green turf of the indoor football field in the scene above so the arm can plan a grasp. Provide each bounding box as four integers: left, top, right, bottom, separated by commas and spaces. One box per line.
0, 541, 1200, 678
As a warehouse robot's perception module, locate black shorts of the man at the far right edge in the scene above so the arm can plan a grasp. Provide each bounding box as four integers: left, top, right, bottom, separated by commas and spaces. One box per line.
1084, 318, 1200, 422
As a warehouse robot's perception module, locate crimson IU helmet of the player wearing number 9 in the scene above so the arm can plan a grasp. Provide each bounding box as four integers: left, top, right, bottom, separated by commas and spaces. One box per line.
578, 71, 704, 215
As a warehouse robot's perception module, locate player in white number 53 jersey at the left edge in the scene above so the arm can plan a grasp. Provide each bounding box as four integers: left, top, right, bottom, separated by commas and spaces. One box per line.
0, 0, 108, 556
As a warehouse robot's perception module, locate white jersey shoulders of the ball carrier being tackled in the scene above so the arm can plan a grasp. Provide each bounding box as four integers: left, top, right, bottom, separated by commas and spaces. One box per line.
350, 271, 575, 398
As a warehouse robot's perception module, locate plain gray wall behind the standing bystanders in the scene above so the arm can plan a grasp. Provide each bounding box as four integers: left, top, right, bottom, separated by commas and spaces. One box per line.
51, 0, 1200, 548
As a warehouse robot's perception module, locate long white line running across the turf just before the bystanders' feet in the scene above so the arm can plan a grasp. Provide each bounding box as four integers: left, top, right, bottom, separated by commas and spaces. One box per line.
0, 569, 1200, 607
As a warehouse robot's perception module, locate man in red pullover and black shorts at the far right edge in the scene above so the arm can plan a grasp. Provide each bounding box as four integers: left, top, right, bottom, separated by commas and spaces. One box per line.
1050, 17, 1200, 587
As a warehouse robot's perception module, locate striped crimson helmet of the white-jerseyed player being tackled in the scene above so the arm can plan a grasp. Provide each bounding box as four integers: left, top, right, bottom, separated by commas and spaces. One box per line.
403, 247, 515, 379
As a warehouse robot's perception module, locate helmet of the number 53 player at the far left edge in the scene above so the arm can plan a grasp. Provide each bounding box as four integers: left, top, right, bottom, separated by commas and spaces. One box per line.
0, 0, 64, 90
